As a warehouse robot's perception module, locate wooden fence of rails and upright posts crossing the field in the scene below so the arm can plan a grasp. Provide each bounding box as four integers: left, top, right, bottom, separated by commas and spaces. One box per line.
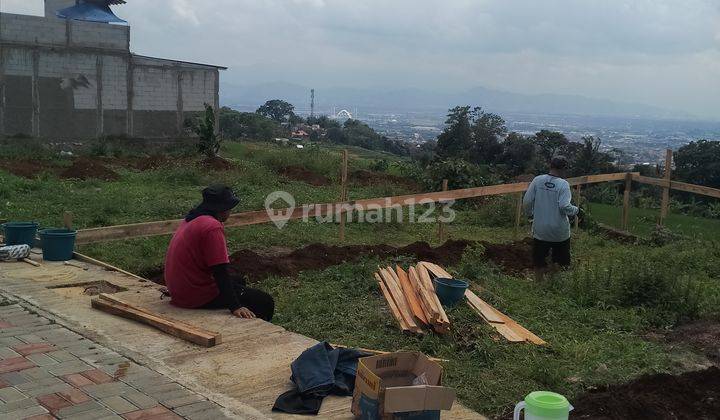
77, 148, 720, 244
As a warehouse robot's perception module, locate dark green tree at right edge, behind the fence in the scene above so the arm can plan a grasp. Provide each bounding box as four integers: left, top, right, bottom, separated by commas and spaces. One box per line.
674, 140, 720, 188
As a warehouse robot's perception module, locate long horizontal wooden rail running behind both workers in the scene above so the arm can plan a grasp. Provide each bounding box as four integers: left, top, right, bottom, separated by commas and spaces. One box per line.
77, 172, 639, 244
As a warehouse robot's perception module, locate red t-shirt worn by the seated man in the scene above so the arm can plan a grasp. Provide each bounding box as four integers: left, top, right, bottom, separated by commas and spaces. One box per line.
165, 216, 230, 308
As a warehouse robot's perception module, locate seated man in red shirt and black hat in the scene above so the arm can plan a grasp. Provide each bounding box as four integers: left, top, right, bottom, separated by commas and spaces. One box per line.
165, 185, 275, 321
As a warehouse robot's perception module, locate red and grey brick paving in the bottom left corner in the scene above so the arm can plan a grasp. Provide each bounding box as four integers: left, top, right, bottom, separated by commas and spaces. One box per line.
0, 298, 227, 420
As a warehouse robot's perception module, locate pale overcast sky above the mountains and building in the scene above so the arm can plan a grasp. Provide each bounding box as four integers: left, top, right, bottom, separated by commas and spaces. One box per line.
5, 0, 720, 120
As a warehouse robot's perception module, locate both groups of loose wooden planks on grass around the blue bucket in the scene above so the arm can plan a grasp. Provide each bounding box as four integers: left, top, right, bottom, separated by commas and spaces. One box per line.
375, 261, 547, 345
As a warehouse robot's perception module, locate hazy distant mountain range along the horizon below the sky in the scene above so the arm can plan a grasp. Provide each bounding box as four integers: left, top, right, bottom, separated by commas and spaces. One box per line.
220, 83, 693, 119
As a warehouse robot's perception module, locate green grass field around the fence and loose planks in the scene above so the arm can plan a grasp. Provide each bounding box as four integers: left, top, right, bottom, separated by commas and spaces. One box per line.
0, 138, 720, 415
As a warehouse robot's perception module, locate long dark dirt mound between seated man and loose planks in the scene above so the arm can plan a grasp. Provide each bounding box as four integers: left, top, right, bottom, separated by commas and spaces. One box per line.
230, 241, 471, 281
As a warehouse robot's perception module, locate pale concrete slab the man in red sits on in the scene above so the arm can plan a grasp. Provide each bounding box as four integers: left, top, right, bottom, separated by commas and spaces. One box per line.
0, 262, 483, 420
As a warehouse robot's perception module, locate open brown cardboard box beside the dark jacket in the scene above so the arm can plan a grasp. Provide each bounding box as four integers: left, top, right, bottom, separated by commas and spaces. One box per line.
352, 352, 455, 420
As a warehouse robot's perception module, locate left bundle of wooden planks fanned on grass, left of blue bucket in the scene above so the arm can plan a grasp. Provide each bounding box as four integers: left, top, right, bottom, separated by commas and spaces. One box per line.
375, 264, 450, 334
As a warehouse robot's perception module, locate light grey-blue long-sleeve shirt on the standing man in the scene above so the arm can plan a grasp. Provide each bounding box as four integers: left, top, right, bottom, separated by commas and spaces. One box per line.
523, 175, 578, 242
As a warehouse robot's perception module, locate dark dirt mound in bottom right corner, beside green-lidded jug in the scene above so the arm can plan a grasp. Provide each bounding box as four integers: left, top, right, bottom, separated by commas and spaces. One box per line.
572, 367, 720, 420
